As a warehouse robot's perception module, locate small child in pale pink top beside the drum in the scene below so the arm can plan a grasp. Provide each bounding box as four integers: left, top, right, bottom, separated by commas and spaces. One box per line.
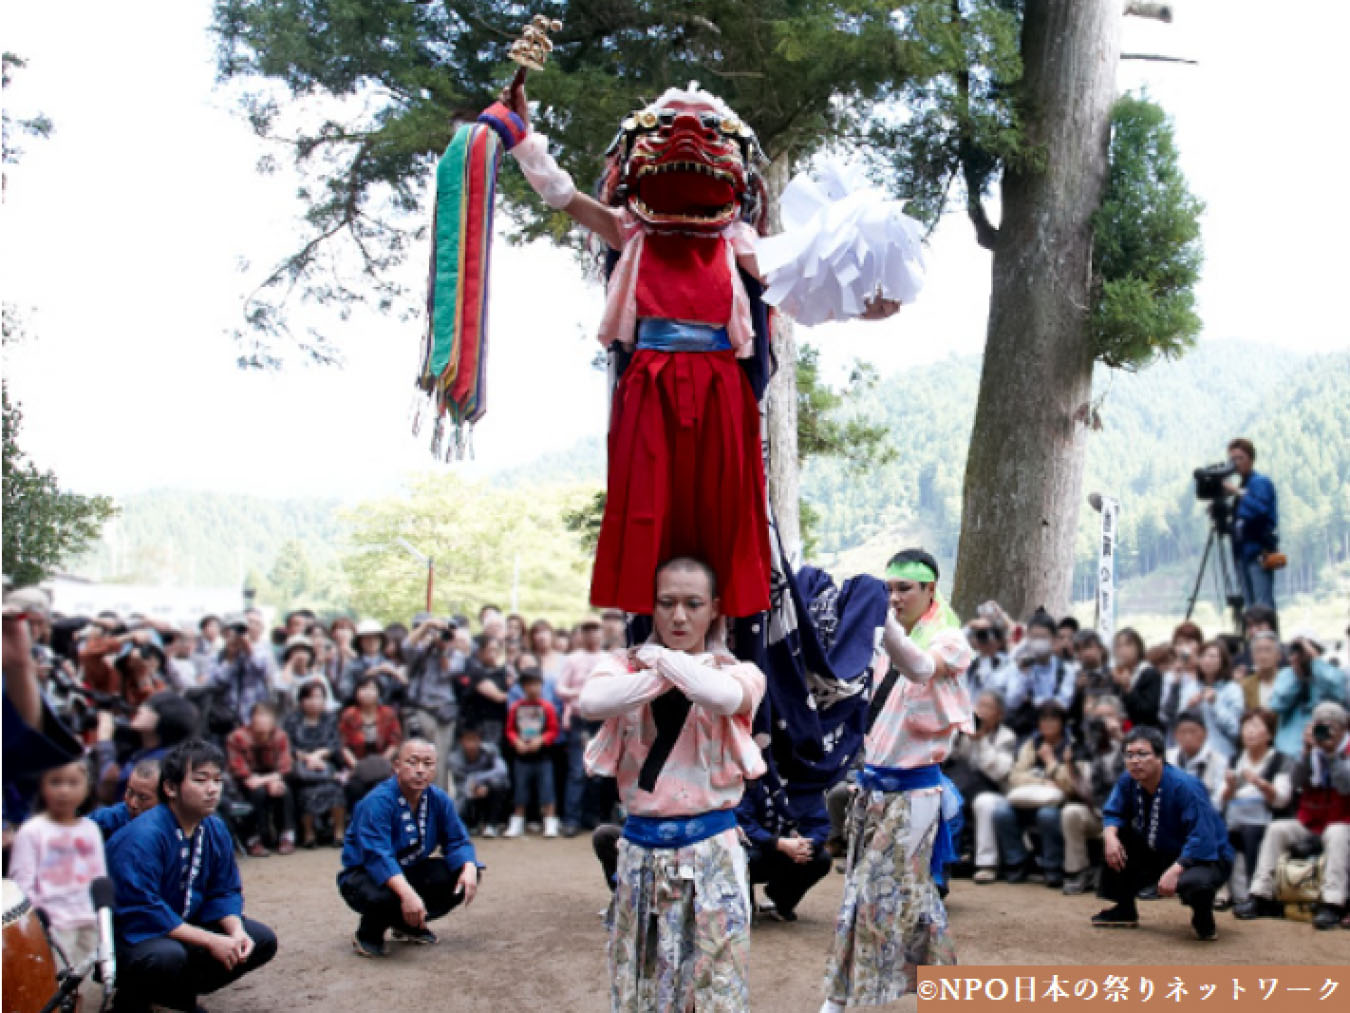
9, 760, 108, 1009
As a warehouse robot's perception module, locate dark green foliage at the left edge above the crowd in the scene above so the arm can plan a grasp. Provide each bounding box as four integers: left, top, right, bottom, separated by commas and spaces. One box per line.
0, 386, 117, 586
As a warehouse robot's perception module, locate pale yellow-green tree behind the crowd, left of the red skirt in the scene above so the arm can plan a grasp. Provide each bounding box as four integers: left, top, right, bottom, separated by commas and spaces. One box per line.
342, 475, 594, 623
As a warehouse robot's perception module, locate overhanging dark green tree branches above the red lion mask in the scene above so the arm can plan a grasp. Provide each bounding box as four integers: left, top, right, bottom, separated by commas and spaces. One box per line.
215, 0, 977, 363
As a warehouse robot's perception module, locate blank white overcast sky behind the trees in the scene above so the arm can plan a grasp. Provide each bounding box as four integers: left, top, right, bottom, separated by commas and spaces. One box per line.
0, 0, 1350, 498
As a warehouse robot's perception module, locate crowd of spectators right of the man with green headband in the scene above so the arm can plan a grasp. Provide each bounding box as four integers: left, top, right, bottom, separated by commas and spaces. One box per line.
945, 602, 1350, 928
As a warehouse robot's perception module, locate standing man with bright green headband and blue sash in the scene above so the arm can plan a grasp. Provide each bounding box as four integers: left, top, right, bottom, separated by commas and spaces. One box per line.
821, 548, 975, 1013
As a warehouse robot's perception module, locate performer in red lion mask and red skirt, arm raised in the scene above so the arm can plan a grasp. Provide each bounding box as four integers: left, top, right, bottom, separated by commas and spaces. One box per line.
494, 85, 917, 617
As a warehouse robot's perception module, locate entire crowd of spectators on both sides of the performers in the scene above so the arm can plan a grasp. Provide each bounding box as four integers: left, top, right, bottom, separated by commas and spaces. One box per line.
5, 593, 1350, 999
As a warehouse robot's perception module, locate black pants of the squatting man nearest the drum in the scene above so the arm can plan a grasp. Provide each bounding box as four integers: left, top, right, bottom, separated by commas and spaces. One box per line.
113, 918, 277, 1013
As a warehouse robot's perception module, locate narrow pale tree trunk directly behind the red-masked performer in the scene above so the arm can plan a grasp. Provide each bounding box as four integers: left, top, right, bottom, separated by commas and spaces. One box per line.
764, 155, 802, 566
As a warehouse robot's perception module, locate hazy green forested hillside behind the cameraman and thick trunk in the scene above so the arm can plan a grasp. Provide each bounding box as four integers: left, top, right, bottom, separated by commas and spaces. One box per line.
802, 342, 1350, 611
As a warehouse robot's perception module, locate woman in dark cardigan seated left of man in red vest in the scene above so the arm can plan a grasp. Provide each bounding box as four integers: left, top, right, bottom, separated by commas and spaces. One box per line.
1219, 708, 1293, 902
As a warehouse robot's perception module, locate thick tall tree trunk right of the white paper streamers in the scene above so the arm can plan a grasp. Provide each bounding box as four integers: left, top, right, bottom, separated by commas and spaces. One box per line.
953, 0, 1123, 617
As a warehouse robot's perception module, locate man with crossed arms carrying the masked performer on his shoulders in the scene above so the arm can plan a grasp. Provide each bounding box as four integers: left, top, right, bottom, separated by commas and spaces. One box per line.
578, 558, 764, 1013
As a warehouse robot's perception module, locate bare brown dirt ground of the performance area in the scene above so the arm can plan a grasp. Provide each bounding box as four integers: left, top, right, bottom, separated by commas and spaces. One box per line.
204, 836, 1350, 1013
